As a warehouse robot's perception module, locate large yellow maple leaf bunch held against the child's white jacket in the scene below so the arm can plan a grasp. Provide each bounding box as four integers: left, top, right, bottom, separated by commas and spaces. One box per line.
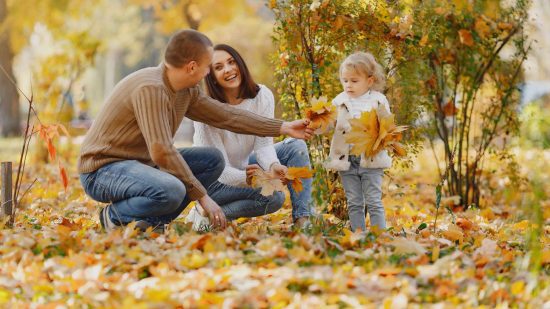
345, 104, 408, 157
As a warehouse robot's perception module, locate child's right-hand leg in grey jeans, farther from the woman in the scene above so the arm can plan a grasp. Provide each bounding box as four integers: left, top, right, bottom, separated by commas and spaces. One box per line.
360, 168, 386, 230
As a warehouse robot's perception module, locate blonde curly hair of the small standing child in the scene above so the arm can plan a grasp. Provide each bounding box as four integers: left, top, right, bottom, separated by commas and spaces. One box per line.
340, 52, 386, 92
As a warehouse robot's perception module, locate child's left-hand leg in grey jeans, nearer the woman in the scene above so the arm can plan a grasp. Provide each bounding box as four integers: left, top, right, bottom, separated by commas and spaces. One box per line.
340, 156, 366, 231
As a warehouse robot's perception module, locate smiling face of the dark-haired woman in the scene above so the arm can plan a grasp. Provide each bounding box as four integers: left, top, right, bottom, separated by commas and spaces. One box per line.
211, 50, 241, 90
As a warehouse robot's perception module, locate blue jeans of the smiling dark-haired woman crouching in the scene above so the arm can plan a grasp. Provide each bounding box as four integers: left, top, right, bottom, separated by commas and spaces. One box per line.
208, 138, 313, 220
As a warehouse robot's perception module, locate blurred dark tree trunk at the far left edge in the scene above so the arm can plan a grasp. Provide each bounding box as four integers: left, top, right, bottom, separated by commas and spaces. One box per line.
0, 0, 21, 137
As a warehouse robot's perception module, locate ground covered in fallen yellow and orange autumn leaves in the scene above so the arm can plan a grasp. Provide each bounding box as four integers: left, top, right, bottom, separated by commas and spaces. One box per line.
0, 143, 550, 308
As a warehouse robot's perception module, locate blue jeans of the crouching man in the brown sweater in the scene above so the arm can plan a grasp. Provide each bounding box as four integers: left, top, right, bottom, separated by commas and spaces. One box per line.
80, 147, 225, 225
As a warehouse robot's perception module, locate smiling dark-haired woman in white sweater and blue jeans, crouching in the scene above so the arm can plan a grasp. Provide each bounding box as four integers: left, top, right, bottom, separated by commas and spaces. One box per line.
193, 44, 312, 226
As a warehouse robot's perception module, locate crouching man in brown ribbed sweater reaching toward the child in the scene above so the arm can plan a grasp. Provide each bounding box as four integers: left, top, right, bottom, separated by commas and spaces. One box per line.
78, 30, 312, 231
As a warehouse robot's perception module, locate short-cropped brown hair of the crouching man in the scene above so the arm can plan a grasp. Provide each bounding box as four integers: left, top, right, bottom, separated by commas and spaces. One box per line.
164, 29, 212, 68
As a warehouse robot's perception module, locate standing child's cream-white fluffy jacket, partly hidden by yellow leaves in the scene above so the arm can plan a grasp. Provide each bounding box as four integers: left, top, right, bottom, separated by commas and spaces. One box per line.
325, 90, 392, 171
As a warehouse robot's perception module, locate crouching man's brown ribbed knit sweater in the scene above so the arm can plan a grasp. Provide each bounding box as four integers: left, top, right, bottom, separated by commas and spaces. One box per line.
78, 64, 282, 200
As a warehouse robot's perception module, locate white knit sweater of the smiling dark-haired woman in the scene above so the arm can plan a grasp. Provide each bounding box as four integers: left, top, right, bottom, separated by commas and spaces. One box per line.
193, 85, 279, 187
